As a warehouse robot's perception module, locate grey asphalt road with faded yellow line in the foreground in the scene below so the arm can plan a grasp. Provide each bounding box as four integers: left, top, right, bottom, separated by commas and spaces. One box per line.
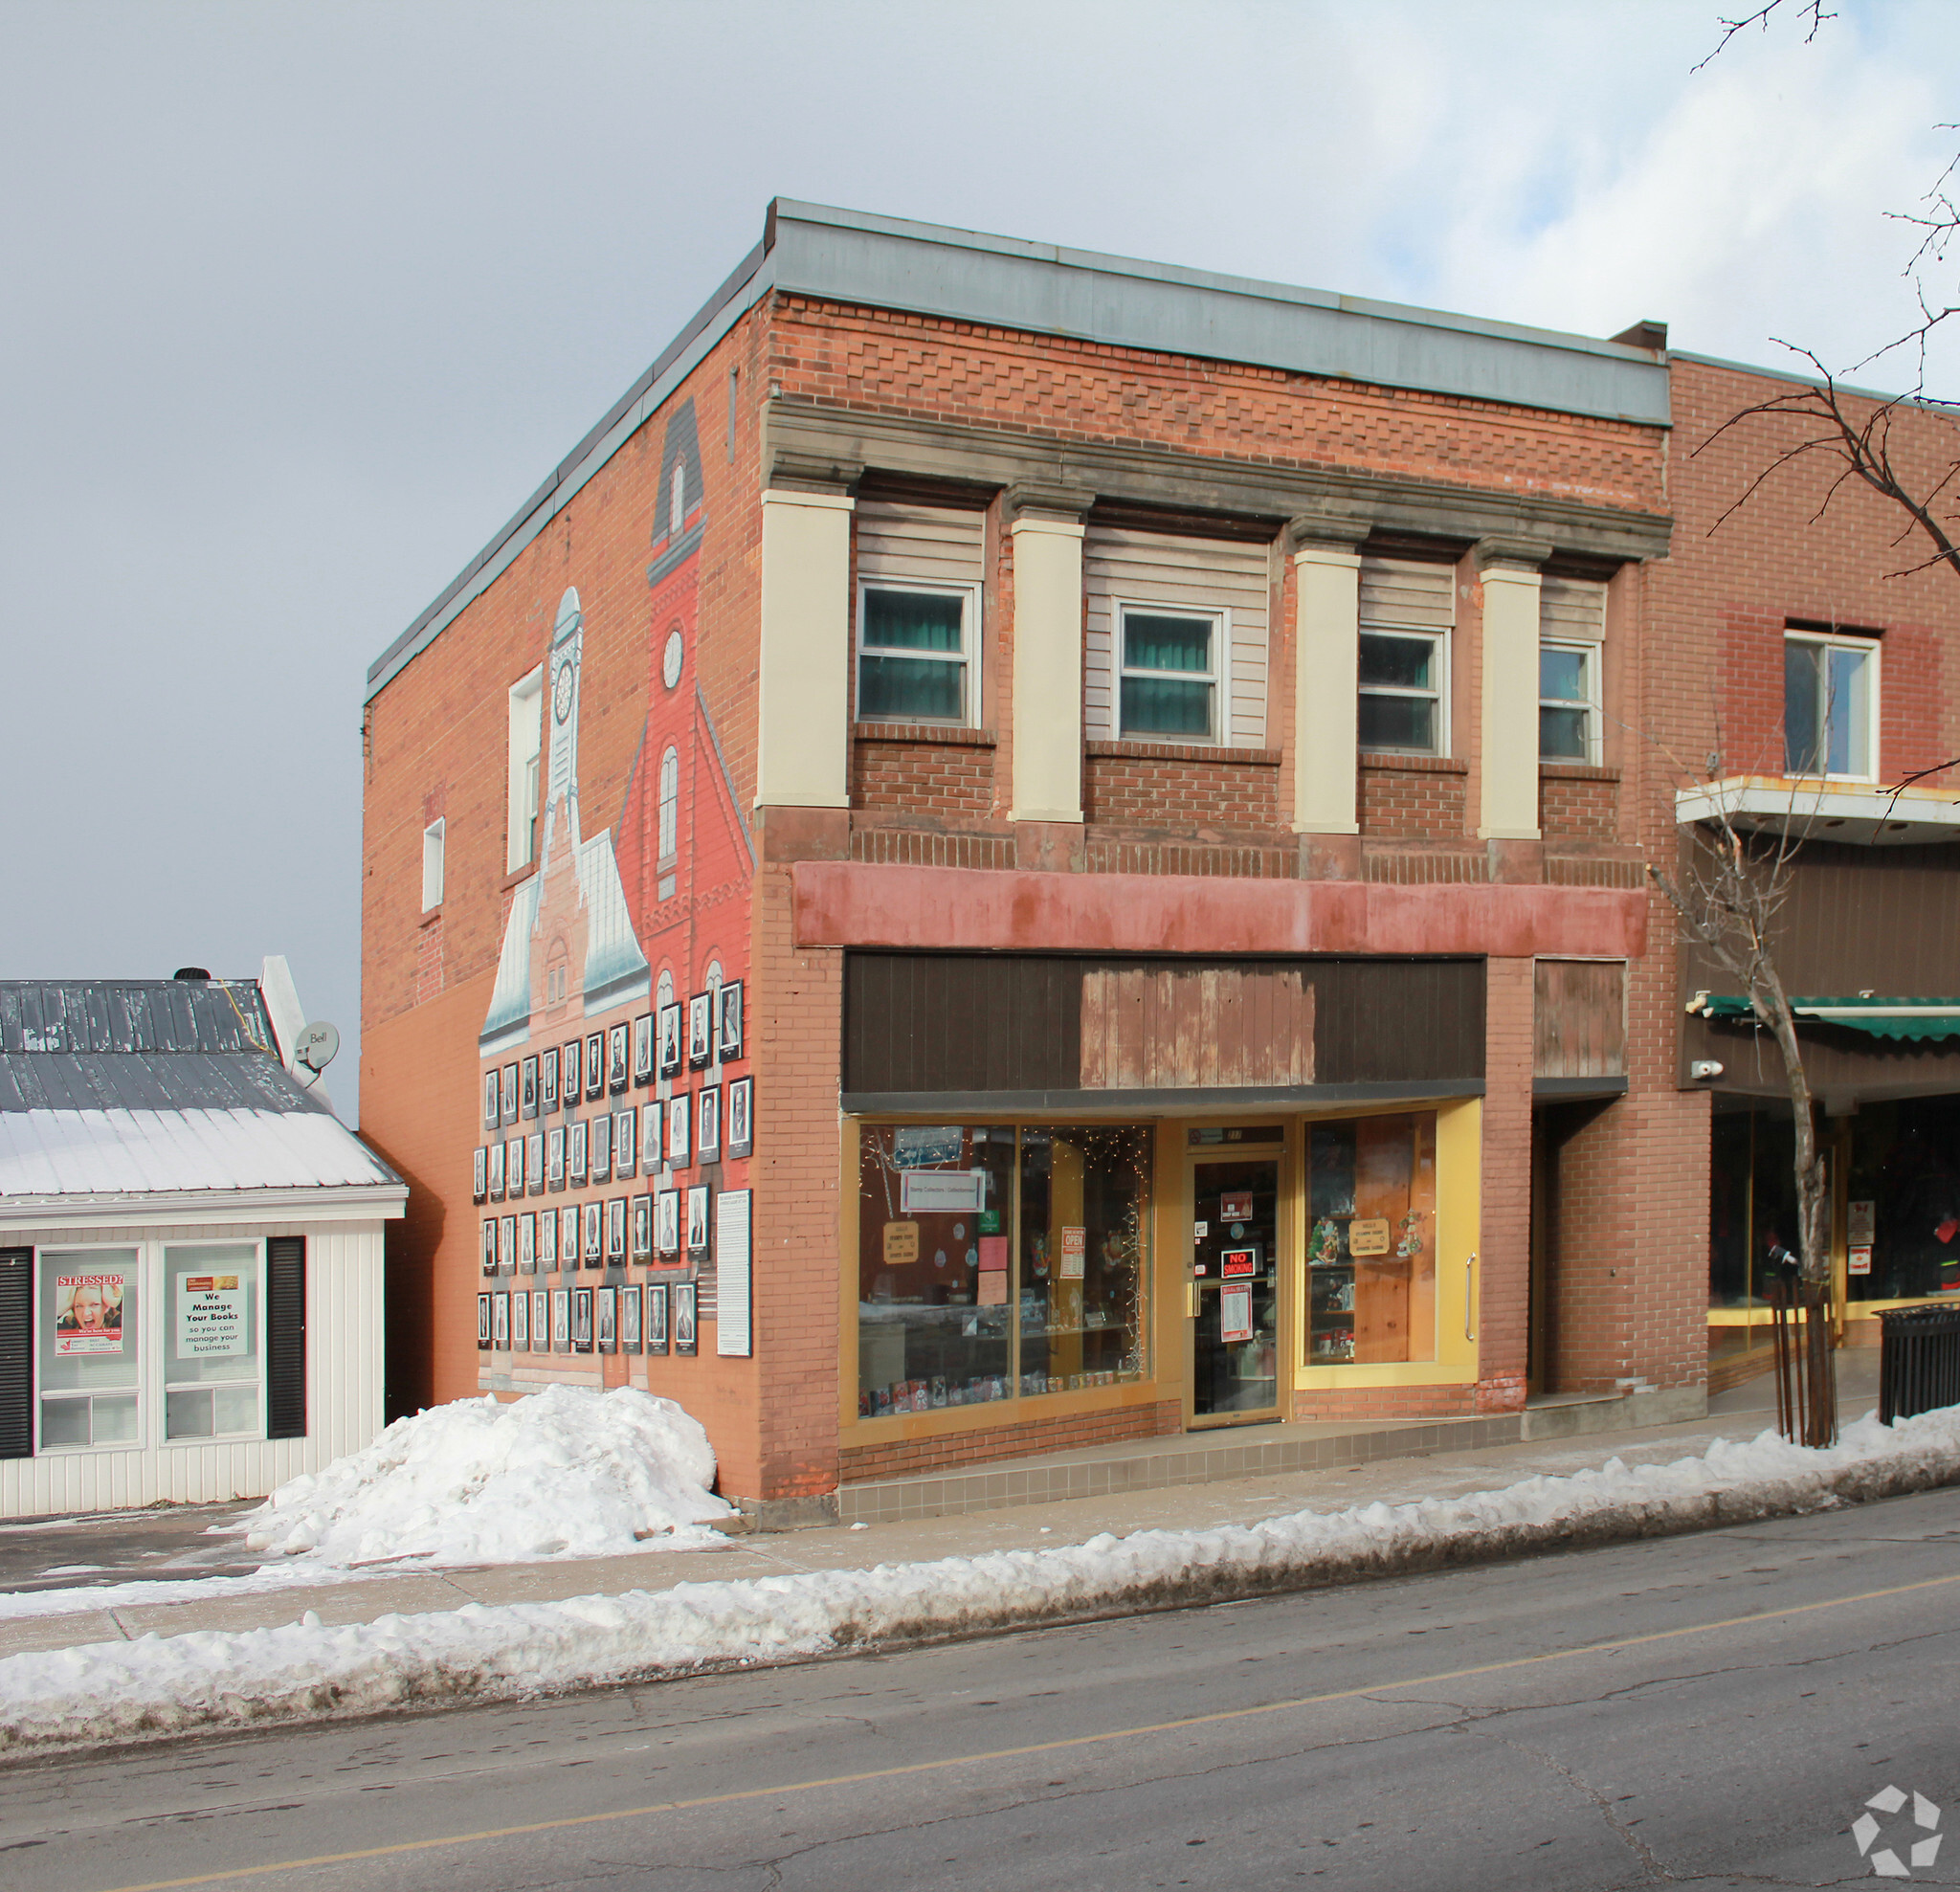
0, 1492, 1960, 1892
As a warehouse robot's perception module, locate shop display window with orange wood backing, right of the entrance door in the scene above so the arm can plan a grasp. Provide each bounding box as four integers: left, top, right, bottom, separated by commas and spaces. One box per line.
1307, 1112, 1437, 1367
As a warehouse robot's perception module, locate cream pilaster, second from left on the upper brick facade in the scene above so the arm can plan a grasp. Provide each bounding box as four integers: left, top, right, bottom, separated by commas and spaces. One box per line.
1010, 514, 1084, 821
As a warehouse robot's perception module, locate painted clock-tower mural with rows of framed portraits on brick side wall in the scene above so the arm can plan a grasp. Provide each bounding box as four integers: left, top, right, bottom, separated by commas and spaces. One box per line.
473, 402, 754, 1384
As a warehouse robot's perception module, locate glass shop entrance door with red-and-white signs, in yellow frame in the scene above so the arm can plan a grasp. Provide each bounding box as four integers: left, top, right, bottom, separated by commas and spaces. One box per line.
1192, 1157, 1280, 1419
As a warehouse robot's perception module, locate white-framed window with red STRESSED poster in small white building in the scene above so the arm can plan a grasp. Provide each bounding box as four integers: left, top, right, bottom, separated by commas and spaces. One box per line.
39, 1249, 144, 1451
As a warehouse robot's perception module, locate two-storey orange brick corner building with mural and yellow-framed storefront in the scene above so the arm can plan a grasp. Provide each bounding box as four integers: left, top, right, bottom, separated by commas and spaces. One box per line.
363, 204, 1960, 1500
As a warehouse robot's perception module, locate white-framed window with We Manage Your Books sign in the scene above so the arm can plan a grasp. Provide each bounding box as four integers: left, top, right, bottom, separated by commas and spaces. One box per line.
163, 1241, 264, 1439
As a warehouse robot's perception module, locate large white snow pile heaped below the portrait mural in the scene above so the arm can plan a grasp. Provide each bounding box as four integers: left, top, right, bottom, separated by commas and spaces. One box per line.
236, 1386, 733, 1569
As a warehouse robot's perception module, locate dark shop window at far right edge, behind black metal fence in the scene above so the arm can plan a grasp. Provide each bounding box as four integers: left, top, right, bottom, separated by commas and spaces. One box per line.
1846, 1098, 1960, 1300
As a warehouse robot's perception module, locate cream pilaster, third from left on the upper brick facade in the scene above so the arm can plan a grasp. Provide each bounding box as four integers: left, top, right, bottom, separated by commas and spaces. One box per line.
1294, 539, 1360, 835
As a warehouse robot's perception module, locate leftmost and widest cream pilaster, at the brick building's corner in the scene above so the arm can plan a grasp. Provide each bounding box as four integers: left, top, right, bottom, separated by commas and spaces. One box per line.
754, 488, 855, 808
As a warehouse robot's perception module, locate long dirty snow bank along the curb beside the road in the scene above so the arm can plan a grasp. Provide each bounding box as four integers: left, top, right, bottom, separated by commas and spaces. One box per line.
0, 1408, 1960, 1755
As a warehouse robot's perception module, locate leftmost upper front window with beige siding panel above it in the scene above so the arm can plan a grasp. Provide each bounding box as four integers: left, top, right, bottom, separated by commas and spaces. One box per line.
853, 500, 984, 727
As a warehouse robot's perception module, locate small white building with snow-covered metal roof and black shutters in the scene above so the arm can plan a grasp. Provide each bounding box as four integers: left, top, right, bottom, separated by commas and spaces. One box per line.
0, 959, 408, 1518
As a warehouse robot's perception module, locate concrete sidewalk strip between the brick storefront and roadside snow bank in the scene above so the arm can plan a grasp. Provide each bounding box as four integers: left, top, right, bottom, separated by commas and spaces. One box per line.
0, 1353, 1876, 1657
